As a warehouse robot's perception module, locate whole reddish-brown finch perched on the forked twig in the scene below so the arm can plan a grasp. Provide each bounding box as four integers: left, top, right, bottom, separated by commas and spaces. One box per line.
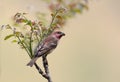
27, 31, 65, 67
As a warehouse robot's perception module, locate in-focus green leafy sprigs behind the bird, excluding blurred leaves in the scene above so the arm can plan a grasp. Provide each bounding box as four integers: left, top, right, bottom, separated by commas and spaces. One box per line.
2, 8, 64, 58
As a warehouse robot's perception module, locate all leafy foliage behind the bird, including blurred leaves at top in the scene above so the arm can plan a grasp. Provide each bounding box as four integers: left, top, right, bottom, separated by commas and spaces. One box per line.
2, 0, 88, 58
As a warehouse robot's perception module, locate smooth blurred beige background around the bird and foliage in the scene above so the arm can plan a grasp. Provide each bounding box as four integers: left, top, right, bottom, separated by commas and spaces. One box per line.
0, 0, 120, 82
